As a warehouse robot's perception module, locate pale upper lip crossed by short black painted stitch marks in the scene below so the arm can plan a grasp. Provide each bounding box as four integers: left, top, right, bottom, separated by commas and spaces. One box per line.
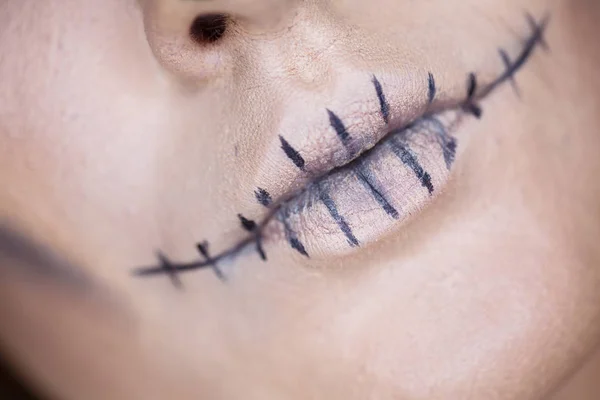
254, 72, 459, 212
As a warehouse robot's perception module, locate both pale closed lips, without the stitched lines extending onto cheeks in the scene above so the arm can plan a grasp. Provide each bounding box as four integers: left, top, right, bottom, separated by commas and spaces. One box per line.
244, 72, 464, 258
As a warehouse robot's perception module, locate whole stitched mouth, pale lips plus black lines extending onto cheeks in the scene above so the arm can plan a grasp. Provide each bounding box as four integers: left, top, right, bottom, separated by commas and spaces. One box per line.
135, 11, 548, 279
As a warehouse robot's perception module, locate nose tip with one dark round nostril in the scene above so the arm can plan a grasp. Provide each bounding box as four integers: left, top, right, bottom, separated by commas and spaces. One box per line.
138, 0, 300, 81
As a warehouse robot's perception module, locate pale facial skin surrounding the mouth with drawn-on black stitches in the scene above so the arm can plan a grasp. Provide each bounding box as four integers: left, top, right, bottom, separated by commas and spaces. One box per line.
0, 0, 600, 400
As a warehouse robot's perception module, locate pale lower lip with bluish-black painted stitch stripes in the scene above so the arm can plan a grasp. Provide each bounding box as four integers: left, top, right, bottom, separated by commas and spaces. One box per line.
268, 112, 457, 259
